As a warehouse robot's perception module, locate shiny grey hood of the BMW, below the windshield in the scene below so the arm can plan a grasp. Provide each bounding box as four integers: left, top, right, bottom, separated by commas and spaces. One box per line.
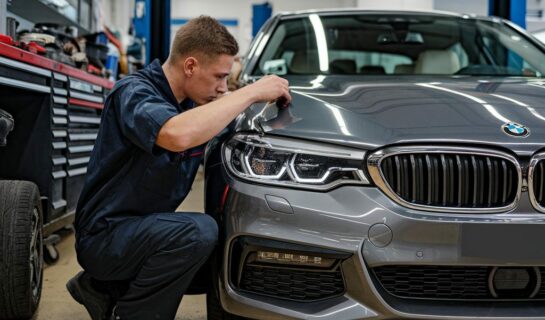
239, 76, 545, 156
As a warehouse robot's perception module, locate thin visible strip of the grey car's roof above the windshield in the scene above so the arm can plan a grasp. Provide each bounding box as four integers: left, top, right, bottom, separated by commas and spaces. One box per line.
277, 8, 494, 19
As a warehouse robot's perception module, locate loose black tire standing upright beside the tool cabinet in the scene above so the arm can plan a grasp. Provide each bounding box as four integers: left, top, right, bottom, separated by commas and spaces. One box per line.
0, 181, 43, 320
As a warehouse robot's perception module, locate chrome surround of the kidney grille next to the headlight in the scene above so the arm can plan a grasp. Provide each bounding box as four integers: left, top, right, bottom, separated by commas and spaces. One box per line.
367, 146, 522, 213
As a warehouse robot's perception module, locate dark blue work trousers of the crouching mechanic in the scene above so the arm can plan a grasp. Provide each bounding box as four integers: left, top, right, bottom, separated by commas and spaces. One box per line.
76, 212, 218, 320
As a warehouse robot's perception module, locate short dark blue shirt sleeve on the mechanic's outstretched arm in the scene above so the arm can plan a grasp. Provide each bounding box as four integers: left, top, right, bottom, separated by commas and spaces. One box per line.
113, 84, 179, 153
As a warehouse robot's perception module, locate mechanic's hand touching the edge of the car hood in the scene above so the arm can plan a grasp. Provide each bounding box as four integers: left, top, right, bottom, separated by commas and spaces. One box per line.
239, 75, 291, 106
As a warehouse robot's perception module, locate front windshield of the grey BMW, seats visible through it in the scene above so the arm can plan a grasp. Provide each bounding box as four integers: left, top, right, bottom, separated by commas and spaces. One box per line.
252, 14, 545, 77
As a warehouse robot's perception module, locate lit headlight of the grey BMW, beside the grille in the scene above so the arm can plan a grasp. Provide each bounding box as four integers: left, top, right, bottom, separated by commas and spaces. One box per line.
223, 134, 369, 190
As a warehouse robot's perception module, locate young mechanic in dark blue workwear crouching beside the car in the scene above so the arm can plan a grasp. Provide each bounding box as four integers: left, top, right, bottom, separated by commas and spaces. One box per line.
67, 16, 291, 320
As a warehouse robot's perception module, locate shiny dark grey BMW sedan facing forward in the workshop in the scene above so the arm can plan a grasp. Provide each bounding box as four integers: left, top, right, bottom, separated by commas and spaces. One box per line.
202, 10, 545, 319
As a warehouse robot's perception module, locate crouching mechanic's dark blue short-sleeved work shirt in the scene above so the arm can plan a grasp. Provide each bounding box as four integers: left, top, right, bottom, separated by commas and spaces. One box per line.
75, 60, 204, 234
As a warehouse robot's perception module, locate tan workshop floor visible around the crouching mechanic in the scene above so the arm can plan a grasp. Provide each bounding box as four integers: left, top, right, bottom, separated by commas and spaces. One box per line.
35, 171, 206, 320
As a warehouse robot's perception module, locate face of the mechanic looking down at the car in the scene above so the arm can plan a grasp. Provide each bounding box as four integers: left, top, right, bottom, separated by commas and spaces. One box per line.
185, 54, 235, 105
